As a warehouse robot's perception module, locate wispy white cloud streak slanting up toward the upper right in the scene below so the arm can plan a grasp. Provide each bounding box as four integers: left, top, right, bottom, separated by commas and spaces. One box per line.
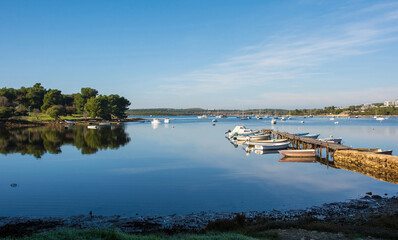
149, 3, 398, 106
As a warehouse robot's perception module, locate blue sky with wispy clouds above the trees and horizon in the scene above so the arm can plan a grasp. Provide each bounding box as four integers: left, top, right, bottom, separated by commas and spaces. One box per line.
0, 0, 398, 109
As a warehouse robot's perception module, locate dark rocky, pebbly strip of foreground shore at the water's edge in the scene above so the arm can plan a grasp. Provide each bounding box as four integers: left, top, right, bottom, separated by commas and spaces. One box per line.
0, 193, 398, 237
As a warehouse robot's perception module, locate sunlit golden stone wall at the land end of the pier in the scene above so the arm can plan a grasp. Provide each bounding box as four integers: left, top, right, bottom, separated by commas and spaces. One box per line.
333, 150, 398, 184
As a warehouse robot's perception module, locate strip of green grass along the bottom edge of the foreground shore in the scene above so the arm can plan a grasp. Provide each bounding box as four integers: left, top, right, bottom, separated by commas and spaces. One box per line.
2, 229, 266, 240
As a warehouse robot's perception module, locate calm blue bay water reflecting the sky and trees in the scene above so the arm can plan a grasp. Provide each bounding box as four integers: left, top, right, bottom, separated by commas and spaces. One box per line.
0, 117, 398, 216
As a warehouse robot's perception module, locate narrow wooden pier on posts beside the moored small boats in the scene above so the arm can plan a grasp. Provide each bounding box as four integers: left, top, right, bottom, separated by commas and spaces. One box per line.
263, 129, 351, 159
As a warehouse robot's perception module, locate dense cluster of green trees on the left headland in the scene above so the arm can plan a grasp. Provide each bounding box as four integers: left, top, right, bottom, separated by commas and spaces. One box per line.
0, 83, 130, 120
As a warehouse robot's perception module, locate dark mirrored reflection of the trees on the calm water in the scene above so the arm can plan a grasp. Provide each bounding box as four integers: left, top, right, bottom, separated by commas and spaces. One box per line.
0, 126, 130, 158
